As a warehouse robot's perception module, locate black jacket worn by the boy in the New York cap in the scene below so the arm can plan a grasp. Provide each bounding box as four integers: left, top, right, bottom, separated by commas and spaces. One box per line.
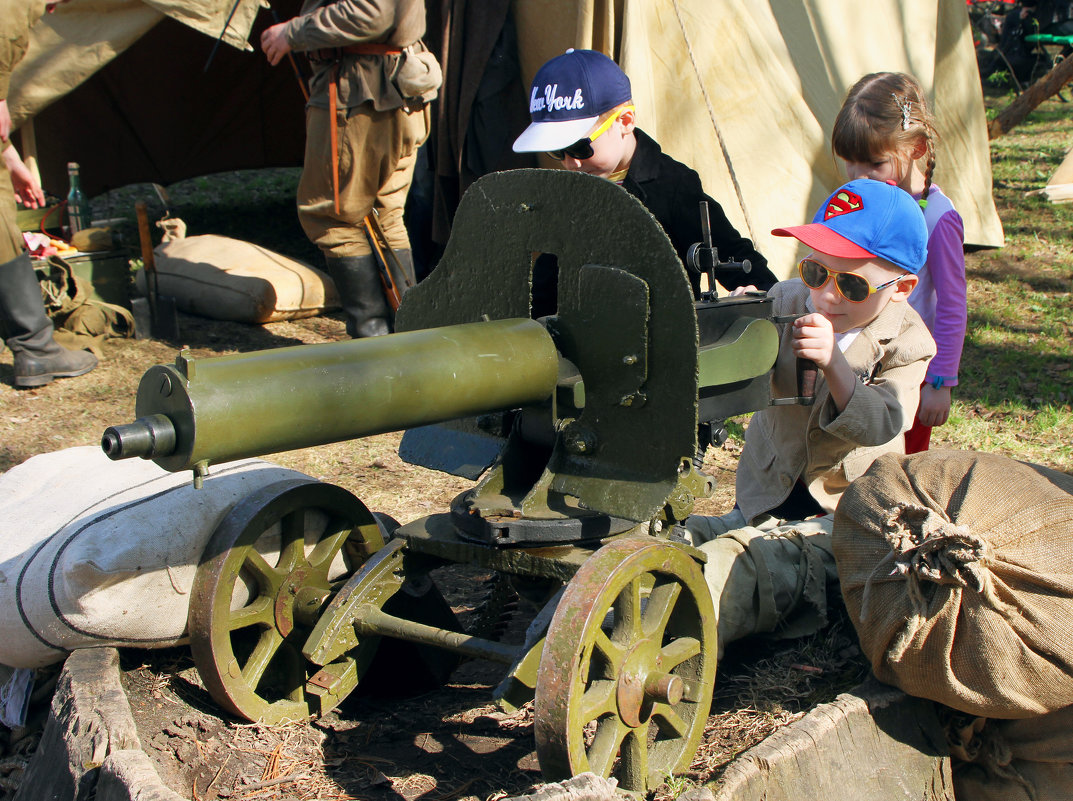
622, 128, 778, 296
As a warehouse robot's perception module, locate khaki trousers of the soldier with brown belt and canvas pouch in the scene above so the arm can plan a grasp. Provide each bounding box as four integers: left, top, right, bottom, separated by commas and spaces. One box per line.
298, 103, 429, 258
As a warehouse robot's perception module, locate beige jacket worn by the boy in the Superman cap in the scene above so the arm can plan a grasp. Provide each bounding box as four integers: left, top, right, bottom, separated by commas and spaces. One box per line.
735, 279, 936, 523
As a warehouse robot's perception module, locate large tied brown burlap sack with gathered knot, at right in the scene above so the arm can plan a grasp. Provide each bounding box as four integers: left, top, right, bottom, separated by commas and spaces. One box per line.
833, 450, 1073, 718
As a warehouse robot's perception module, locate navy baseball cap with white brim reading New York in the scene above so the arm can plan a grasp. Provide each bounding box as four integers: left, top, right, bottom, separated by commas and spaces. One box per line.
514, 48, 633, 153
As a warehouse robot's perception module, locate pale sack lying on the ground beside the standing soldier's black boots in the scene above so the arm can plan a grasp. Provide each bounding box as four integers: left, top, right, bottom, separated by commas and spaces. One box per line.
135, 234, 339, 324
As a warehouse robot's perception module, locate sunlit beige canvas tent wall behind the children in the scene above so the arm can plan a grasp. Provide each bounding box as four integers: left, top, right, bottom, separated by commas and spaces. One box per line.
515, 0, 1002, 276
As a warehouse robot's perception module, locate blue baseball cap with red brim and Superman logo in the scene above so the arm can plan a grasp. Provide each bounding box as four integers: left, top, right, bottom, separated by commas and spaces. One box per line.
771, 178, 928, 276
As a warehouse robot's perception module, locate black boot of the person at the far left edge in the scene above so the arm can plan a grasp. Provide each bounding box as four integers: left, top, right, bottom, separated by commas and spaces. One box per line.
0, 253, 97, 387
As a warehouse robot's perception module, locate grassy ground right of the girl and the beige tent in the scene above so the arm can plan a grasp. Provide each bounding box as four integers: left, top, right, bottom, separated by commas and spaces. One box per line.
932, 95, 1073, 472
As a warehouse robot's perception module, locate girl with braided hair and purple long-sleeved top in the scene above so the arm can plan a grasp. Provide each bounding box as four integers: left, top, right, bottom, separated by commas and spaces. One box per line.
831, 72, 968, 454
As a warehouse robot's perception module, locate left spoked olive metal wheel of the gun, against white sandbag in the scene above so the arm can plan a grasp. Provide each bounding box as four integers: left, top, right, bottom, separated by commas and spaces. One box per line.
188, 479, 384, 723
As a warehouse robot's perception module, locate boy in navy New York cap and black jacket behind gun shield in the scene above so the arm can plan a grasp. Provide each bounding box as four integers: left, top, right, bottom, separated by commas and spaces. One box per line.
514, 49, 776, 306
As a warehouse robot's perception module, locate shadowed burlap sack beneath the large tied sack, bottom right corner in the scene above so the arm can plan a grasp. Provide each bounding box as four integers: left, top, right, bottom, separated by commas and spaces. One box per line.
946, 707, 1073, 801
